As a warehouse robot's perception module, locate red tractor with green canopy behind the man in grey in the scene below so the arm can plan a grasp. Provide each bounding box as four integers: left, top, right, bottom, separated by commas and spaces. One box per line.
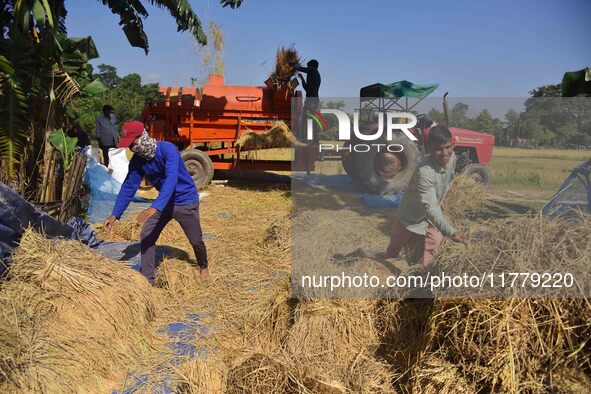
343, 81, 495, 194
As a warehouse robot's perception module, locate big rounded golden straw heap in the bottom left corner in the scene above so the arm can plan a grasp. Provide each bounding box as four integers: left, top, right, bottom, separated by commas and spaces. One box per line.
0, 230, 154, 392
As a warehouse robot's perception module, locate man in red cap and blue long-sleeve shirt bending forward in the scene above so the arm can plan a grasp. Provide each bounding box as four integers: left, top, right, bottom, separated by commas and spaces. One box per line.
105, 121, 209, 283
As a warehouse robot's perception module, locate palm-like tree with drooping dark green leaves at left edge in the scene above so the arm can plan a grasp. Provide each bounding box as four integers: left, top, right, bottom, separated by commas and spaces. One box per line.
0, 0, 242, 189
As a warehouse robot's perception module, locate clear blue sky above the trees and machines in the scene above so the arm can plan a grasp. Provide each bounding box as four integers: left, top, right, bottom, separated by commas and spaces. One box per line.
66, 0, 591, 97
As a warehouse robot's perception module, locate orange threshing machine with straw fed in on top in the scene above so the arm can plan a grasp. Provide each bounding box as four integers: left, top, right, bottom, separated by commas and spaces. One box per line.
143, 75, 317, 187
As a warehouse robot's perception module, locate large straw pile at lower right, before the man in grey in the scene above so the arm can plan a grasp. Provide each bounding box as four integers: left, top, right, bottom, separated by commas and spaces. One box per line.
408, 217, 591, 392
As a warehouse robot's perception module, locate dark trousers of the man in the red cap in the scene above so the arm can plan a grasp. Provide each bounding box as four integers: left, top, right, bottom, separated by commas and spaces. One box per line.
140, 203, 207, 283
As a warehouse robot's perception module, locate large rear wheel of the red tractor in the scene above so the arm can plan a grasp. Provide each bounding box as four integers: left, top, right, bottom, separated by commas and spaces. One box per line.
343, 133, 421, 194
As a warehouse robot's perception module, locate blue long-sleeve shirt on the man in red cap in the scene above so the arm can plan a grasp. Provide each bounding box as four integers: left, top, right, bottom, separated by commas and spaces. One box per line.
112, 141, 199, 219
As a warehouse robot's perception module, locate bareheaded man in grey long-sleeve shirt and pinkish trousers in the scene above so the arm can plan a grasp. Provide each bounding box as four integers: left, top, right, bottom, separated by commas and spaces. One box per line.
386, 126, 465, 268
